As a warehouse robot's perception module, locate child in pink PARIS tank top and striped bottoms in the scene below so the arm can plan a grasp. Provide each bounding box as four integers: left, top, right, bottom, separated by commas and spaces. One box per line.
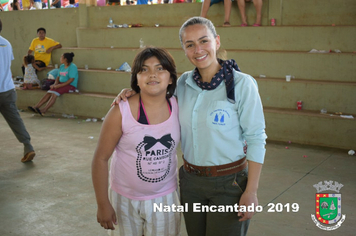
92, 47, 181, 236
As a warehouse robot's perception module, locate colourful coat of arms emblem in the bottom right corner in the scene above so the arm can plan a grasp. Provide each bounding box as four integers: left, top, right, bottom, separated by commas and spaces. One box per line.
311, 181, 346, 231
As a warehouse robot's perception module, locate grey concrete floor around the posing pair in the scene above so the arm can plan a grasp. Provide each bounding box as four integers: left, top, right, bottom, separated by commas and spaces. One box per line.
0, 112, 356, 236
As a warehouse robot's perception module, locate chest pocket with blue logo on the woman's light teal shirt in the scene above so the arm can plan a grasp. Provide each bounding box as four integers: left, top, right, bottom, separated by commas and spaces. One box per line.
206, 101, 238, 131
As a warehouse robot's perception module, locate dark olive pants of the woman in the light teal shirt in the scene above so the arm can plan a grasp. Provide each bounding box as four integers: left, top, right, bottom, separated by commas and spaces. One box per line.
179, 167, 250, 236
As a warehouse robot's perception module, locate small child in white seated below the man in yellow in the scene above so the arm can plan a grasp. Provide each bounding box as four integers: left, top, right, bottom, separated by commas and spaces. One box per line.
22, 55, 46, 89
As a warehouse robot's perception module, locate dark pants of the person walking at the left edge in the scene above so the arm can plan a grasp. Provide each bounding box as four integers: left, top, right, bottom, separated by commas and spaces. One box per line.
0, 89, 33, 154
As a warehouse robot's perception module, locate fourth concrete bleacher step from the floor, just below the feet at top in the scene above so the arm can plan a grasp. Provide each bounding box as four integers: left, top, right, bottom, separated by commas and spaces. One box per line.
77, 26, 356, 52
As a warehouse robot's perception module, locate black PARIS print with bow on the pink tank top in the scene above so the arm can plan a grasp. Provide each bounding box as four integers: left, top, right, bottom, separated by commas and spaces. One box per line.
136, 134, 175, 183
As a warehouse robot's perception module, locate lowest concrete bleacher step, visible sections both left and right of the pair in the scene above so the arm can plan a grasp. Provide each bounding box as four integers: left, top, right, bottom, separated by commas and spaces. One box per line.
17, 90, 356, 148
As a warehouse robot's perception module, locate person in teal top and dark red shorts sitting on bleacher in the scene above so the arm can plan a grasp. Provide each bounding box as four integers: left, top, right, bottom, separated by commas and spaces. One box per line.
28, 52, 78, 116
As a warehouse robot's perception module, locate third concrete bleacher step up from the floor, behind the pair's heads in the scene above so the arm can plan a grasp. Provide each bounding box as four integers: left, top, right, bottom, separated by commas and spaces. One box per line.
52, 48, 356, 82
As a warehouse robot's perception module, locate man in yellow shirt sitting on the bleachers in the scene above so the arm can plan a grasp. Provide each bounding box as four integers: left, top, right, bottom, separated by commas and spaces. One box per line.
23, 28, 62, 72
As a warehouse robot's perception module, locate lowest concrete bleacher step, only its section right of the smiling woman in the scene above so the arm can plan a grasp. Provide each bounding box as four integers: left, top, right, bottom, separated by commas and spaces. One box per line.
264, 107, 356, 149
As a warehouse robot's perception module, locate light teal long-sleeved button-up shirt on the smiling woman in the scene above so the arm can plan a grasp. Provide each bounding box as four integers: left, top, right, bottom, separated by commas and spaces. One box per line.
176, 70, 267, 166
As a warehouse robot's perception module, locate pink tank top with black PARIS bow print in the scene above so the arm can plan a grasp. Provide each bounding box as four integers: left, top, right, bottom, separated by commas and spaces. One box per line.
110, 97, 180, 200
